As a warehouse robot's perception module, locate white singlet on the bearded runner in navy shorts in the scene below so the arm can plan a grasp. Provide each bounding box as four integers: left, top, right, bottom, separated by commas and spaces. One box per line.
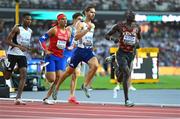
78, 22, 94, 49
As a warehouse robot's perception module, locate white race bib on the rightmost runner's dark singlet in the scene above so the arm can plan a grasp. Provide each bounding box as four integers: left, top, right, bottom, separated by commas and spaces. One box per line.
123, 35, 136, 45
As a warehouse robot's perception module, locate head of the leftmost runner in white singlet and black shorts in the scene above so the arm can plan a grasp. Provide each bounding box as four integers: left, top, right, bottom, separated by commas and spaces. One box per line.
22, 13, 32, 27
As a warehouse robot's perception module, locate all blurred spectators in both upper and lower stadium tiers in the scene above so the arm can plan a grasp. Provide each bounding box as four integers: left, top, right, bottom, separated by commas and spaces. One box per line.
0, 0, 180, 69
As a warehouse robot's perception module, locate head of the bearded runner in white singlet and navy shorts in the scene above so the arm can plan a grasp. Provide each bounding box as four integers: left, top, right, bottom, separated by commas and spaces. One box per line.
83, 5, 96, 20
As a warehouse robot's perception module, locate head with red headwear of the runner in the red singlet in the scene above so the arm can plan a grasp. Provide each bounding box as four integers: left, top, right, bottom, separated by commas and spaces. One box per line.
57, 14, 67, 27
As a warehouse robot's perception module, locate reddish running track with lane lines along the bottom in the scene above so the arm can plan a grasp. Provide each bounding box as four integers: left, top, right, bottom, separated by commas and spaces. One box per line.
0, 100, 180, 119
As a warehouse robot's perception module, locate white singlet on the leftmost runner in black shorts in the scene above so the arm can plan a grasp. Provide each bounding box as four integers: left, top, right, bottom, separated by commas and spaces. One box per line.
7, 25, 32, 56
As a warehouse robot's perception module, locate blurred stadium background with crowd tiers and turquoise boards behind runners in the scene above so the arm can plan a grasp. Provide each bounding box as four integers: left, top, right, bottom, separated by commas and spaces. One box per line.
0, 0, 180, 91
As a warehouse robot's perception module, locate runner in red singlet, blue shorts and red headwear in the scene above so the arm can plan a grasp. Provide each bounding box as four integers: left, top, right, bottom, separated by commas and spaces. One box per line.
39, 14, 70, 104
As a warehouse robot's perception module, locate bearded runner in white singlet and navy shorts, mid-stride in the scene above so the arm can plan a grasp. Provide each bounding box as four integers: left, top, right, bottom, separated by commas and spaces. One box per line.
56, 6, 98, 98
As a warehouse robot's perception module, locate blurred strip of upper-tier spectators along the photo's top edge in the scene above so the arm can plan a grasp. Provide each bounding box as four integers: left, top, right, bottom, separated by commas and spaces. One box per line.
0, 0, 180, 11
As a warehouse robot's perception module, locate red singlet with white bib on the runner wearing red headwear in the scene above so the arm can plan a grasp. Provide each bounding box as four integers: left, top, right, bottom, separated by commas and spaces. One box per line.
48, 26, 69, 57
